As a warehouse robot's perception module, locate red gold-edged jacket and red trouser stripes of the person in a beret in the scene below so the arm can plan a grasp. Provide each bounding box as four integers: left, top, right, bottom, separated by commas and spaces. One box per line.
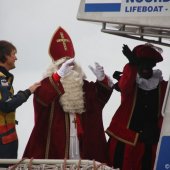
106, 64, 167, 170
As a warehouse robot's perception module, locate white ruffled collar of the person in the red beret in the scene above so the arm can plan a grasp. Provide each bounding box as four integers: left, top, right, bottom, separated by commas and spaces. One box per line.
136, 69, 163, 90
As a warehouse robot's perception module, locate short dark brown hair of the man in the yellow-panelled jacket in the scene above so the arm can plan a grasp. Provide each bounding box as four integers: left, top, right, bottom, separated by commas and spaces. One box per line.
0, 40, 17, 63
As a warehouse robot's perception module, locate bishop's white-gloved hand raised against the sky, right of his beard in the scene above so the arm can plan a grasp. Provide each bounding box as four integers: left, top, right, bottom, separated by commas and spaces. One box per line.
89, 63, 105, 81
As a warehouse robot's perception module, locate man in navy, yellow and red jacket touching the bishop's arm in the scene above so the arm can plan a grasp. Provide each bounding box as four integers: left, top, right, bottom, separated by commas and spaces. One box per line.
0, 40, 40, 167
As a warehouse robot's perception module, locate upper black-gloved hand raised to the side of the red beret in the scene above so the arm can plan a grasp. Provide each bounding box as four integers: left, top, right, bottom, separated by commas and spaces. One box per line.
122, 44, 139, 65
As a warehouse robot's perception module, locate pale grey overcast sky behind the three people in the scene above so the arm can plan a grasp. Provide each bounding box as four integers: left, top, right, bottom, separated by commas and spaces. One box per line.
0, 0, 170, 158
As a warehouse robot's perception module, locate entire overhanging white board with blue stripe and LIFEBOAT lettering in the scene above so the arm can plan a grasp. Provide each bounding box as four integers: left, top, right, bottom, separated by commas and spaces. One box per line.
77, 0, 170, 28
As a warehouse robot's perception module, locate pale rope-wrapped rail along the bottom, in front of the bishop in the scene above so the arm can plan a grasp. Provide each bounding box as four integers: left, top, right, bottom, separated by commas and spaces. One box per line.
0, 159, 118, 170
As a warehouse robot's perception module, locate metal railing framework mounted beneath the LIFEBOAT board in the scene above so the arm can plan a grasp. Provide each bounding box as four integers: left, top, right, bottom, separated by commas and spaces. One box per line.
101, 22, 170, 47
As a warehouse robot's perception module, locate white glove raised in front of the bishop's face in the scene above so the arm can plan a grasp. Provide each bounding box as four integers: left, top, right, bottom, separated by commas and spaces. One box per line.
57, 58, 74, 77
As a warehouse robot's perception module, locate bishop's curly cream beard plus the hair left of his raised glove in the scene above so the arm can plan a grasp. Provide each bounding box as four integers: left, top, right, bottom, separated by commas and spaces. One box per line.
43, 58, 86, 114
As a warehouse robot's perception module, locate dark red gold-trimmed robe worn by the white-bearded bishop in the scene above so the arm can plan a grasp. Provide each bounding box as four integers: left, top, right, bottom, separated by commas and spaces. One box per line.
23, 77, 112, 162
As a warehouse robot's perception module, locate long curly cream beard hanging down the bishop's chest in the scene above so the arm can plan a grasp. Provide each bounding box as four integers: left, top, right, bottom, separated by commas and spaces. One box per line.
60, 70, 85, 114
